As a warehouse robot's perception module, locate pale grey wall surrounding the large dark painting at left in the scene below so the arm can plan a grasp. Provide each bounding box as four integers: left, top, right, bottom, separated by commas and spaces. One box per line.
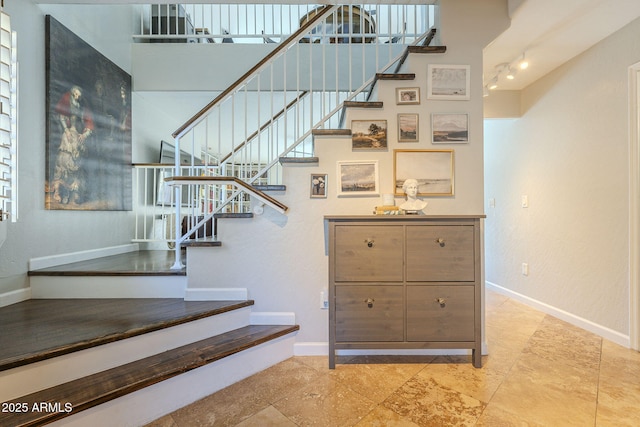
0, 0, 138, 296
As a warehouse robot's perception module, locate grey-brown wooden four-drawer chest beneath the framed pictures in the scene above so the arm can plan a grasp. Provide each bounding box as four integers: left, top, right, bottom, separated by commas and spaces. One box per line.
325, 215, 483, 368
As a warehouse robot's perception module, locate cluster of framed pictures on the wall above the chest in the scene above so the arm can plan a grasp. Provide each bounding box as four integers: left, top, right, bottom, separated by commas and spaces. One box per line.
310, 64, 472, 202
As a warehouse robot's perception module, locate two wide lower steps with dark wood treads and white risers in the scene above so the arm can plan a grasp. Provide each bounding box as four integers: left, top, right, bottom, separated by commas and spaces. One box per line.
0, 298, 298, 427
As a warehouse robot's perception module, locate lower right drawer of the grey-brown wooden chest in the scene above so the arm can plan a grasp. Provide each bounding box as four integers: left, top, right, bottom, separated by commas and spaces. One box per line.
407, 285, 475, 341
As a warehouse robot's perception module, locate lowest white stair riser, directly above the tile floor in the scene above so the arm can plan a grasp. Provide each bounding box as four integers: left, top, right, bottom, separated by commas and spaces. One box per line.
50, 334, 295, 427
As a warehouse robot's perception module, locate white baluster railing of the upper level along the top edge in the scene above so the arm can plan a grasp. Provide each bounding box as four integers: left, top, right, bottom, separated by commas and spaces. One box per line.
134, 3, 435, 43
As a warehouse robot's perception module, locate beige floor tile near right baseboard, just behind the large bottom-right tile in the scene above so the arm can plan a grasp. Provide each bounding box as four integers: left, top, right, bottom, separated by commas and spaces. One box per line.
524, 316, 602, 370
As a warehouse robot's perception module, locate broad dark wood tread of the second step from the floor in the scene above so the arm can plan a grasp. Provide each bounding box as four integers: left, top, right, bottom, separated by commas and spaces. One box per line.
0, 298, 254, 372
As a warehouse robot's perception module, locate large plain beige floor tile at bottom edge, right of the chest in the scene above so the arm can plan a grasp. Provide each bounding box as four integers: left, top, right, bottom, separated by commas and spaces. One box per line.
491, 354, 598, 426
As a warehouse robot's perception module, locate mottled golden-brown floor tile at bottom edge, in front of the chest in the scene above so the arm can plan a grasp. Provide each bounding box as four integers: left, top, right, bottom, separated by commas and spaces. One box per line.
382, 375, 485, 426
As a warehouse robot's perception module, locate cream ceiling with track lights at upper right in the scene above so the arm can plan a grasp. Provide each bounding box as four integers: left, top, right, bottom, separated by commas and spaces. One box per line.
34, 0, 640, 90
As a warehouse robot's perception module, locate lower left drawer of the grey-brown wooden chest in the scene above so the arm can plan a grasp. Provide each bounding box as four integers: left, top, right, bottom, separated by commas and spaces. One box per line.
335, 285, 404, 342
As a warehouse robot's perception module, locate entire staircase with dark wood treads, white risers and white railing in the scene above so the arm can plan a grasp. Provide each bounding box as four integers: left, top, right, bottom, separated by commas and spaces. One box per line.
7, 6, 444, 426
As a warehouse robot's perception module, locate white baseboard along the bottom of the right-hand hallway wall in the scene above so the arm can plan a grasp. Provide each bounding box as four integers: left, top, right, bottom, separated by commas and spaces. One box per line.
485, 281, 631, 348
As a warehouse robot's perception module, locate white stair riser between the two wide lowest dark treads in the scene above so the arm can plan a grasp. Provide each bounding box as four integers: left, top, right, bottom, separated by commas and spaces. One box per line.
0, 307, 252, 402
